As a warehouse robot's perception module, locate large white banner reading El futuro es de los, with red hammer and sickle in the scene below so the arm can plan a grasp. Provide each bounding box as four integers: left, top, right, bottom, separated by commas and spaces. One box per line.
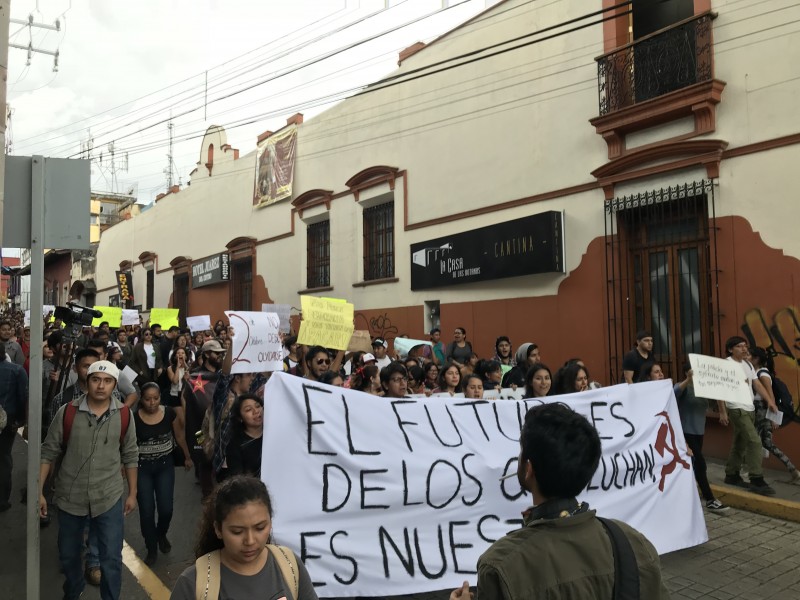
262, 373, 708, 597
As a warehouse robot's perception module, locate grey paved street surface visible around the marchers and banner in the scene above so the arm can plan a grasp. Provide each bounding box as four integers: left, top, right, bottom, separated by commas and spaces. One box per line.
0, 440, 800, 600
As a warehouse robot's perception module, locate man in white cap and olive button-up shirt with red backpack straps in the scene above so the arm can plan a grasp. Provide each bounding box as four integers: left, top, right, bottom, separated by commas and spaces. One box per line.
39, 360, 139, 600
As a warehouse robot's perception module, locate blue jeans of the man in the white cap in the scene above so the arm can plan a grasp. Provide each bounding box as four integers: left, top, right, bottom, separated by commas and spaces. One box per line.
58, 498, 124, 600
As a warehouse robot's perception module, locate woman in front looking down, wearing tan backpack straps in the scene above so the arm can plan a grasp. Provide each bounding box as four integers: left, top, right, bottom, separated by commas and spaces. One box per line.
170, 476, 317, 600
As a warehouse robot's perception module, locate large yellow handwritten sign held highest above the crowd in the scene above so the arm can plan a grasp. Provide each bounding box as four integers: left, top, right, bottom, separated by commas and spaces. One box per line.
297, 296, 354, 350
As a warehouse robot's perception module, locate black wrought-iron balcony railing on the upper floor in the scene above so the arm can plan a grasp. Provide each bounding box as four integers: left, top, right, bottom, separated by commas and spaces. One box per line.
597, 12, 715, 116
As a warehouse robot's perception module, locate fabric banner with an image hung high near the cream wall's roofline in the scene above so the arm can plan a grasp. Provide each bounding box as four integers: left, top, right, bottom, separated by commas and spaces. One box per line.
253, 126, 297, 206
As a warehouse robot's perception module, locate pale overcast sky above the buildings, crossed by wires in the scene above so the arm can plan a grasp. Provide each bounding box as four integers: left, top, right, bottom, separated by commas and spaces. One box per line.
8, 0, 497, 203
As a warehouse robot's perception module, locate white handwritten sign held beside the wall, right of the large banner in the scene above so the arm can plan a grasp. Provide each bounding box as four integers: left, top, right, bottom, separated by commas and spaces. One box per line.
689, 354, 753, 410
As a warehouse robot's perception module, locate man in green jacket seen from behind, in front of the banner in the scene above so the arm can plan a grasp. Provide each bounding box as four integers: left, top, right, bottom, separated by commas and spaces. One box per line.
450, 403, 669, 600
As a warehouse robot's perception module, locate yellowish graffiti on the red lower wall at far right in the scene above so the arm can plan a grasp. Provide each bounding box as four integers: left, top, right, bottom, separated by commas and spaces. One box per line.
742, 306, 800, 406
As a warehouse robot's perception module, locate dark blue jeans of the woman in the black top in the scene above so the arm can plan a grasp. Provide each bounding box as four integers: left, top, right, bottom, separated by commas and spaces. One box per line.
136, 456, 175, 552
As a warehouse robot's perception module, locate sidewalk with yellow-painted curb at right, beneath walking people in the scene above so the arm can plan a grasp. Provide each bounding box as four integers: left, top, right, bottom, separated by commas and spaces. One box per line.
706, 457, 800, 523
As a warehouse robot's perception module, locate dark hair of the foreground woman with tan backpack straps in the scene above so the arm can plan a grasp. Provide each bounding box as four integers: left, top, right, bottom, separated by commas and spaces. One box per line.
194, 475, 272, 558
